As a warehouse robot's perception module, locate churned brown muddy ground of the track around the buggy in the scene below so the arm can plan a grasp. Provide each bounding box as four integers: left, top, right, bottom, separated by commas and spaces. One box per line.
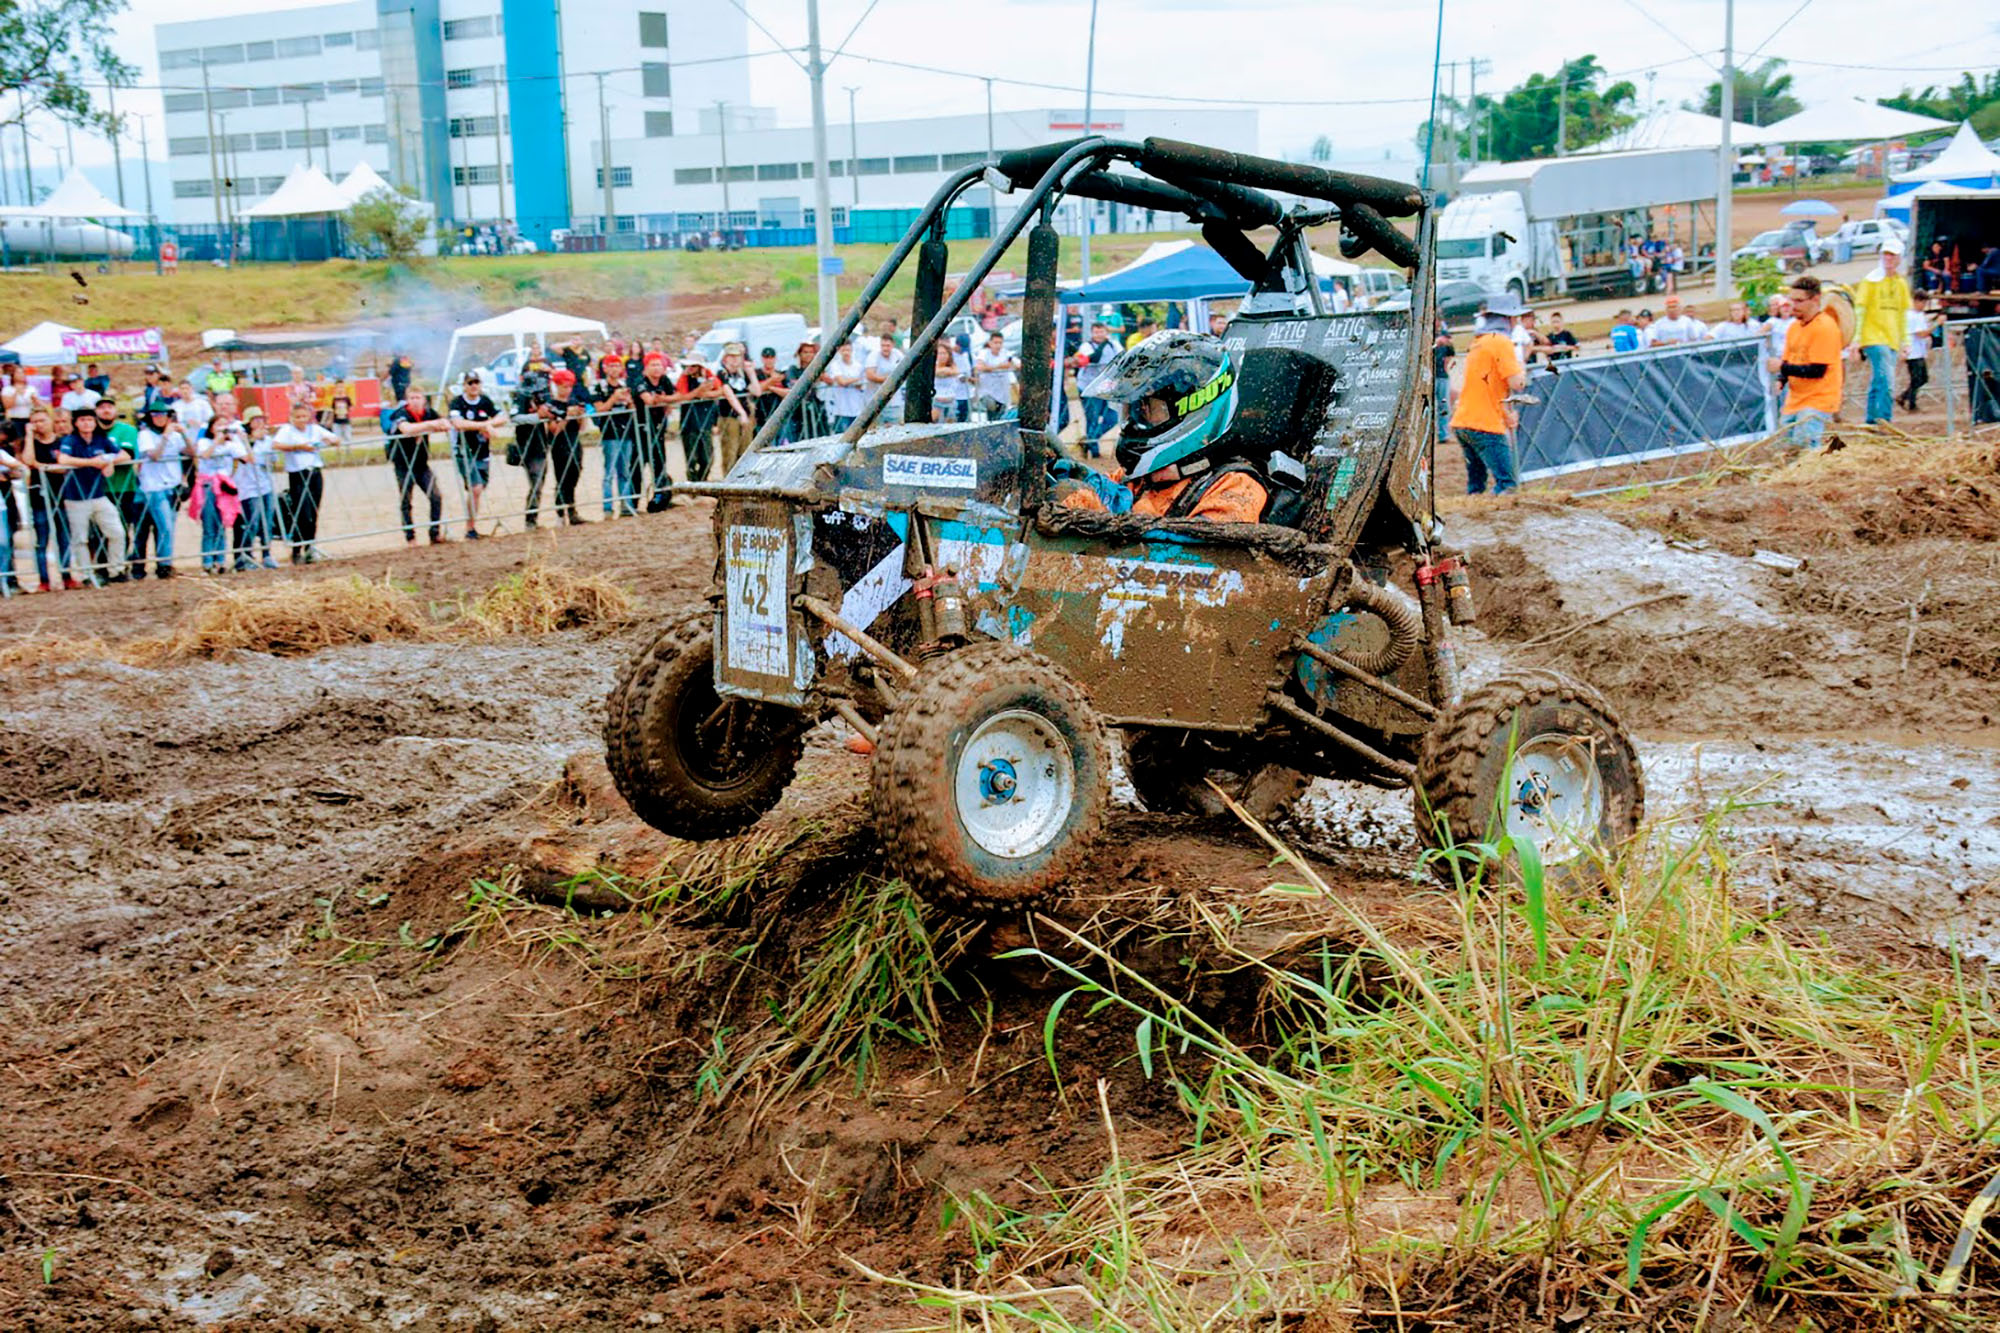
0, 434, 2000, 1329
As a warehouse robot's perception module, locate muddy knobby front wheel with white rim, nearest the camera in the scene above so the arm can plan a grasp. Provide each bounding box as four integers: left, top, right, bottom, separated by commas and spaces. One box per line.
872, 642, 1110, 915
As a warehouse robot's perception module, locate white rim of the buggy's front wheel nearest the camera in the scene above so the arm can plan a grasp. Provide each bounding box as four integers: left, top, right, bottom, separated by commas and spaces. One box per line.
952, 709, 1076, 861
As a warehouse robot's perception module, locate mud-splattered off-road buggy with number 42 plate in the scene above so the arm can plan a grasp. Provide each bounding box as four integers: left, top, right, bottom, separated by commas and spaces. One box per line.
606, 138, 1642, 913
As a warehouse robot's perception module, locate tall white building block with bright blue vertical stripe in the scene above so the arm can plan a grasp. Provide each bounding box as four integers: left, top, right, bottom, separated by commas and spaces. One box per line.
154, 0, 750, 246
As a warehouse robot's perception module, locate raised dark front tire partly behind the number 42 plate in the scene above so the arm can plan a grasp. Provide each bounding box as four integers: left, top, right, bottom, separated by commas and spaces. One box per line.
604, 608, 804, 843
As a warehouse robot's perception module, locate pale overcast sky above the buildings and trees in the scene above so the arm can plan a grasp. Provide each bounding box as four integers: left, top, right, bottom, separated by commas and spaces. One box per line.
50, 0, 2000, 164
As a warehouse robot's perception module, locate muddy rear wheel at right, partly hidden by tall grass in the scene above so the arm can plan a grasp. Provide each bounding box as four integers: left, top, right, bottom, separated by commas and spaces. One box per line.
1416, 671, 1646, 879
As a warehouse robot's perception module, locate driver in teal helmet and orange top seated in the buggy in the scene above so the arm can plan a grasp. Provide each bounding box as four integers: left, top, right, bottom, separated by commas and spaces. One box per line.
1054, 328, 1270, 522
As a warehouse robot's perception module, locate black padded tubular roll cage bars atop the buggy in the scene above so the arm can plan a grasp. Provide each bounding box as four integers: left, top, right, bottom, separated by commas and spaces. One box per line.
736, 136, 1426, 490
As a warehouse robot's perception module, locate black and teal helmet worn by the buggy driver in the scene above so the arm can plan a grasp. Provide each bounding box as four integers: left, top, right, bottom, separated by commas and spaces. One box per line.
1082, 328, 1236, 480
